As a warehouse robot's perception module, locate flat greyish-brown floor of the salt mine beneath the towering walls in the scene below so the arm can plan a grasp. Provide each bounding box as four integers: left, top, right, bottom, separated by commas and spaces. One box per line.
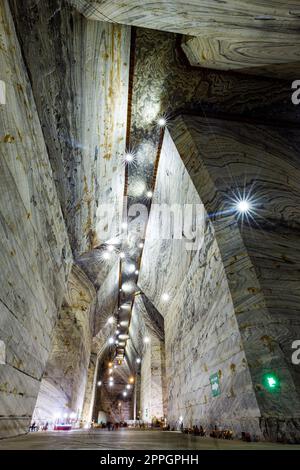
0, 429, 300, 450
